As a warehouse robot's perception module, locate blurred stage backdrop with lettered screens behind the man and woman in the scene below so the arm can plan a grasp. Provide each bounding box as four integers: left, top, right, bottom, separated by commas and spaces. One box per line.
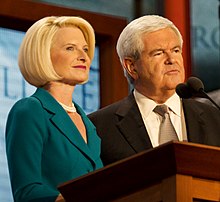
0, 0, 220, 202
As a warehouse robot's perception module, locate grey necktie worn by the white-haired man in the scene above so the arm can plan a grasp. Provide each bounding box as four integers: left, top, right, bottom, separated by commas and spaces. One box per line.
153, 105, 178, 144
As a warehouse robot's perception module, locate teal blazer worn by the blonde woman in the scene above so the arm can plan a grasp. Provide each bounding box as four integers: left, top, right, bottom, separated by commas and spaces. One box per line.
6, 88, 103, 202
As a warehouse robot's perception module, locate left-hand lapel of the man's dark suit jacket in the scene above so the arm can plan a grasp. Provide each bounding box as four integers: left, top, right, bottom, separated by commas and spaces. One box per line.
116, 93, 152, 152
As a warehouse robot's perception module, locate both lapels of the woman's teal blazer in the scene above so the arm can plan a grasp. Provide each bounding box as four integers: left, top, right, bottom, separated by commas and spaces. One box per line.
33, 88, 98, 164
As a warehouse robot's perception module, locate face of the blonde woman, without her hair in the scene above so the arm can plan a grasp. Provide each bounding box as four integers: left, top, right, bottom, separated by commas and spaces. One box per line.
51, 27, 91, 85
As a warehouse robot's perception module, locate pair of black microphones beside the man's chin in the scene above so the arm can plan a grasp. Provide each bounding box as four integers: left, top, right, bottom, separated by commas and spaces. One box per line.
176, 77, 220, 110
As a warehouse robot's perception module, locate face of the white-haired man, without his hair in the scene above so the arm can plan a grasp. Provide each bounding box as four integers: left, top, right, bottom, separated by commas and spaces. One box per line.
131, 28, 185, 97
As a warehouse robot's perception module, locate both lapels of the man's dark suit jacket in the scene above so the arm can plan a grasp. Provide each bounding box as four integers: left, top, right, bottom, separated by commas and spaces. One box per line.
116, 94, 207, 148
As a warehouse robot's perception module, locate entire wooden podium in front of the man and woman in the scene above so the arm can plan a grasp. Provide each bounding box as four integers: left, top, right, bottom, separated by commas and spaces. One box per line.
58, 142, 220, 202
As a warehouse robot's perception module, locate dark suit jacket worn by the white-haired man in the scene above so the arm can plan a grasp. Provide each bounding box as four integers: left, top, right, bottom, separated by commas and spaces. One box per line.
89, 93, 220, 165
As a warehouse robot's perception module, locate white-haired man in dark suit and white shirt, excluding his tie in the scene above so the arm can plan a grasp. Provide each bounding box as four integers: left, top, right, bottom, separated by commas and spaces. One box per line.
89, 15, 220, 165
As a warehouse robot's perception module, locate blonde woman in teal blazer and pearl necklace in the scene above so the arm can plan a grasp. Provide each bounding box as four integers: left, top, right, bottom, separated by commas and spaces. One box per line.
6, 17, 103, 202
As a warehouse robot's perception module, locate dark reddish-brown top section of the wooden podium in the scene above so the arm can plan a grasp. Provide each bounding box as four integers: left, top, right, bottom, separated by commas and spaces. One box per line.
58, 142, 220, 201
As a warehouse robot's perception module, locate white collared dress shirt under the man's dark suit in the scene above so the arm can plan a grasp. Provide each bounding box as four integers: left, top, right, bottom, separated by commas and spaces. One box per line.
134, 90, 187, 147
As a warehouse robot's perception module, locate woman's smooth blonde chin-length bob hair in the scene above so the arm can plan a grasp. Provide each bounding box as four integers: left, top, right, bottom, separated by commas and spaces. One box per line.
18, 16, 95, 87
